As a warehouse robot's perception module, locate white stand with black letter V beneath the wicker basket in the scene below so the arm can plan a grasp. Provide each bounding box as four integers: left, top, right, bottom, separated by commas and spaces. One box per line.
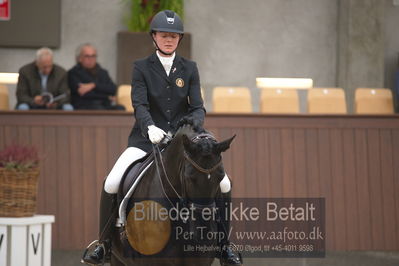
0, 215, 54, 266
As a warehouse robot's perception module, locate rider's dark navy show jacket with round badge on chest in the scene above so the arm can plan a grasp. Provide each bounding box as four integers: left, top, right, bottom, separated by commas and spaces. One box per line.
128, 53, 205, 152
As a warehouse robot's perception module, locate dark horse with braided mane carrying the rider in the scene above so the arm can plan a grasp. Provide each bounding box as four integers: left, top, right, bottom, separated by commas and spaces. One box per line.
111, 125, 234, 266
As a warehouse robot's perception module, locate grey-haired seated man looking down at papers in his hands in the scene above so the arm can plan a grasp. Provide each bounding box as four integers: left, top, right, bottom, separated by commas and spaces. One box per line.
16, 47, 73, 110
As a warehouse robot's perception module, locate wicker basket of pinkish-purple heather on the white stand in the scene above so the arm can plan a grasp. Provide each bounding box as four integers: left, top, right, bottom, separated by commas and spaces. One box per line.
0, 144, 39, 217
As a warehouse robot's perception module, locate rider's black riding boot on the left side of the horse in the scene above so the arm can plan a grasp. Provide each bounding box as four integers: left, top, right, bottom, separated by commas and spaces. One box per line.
82, 186, 117, 265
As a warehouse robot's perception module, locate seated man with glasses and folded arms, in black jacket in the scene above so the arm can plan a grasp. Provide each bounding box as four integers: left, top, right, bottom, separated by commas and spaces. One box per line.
68, 43, 125, 110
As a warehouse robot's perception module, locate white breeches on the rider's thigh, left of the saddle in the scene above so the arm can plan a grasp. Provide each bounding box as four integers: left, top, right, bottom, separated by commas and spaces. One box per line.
104, 147, 147, 194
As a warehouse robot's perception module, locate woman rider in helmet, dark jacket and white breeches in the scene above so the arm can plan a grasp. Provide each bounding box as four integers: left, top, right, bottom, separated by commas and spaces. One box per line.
83, 10, 241, 265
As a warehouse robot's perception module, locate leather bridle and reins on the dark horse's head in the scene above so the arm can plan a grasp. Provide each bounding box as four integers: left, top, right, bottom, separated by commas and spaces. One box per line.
153, 133, 222, 210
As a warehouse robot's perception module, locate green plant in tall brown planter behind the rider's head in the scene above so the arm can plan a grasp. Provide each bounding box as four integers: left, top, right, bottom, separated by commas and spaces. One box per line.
117, 0, 191, 85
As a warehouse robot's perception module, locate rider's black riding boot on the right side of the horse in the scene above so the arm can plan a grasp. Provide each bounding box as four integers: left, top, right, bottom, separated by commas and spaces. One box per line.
216, 192, 242, 266
